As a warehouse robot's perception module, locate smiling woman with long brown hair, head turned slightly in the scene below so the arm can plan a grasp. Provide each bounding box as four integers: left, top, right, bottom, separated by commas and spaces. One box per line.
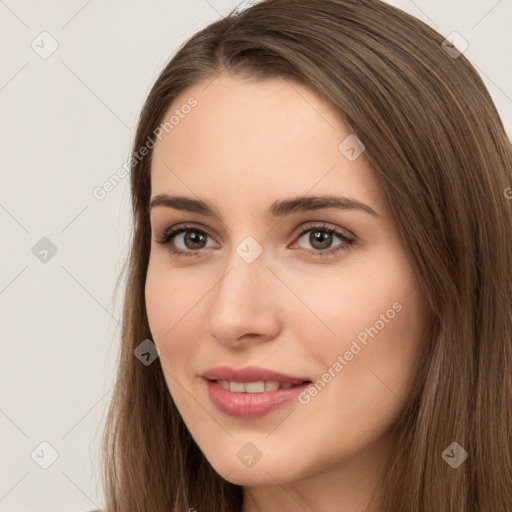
99, 0, 512, 512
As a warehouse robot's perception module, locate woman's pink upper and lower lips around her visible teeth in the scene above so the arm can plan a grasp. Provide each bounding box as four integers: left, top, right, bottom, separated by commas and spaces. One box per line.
202, 366, 311, 418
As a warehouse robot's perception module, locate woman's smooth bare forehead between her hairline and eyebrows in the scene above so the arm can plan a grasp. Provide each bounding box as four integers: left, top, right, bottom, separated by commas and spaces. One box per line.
151, 75, 383, 214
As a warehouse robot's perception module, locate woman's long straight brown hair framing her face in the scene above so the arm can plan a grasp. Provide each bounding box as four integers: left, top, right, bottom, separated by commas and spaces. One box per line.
102, 0, 512, 512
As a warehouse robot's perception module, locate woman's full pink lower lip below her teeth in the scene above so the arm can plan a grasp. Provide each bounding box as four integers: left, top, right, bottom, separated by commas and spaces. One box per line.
205, 379, 311, 418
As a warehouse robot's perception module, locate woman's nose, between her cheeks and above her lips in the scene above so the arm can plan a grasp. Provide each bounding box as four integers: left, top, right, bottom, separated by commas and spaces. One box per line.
206, 250, 279, 347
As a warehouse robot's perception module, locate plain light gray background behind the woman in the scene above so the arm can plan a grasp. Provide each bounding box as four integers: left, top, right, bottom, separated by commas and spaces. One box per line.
0, 0, 512, 512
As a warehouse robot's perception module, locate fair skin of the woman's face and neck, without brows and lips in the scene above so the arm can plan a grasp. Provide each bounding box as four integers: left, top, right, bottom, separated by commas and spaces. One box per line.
145, 74, 427, 512
